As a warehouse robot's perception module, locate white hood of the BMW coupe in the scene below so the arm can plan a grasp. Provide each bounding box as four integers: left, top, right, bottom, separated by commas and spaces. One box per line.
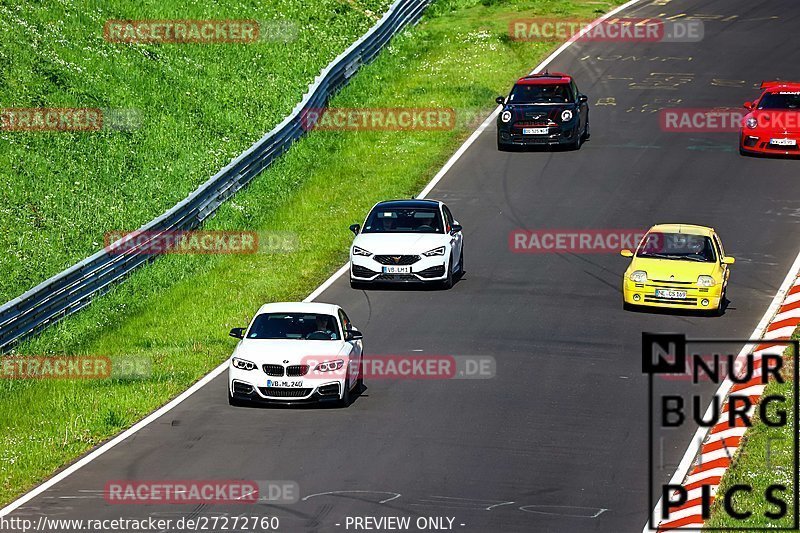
233, 339, 349, 365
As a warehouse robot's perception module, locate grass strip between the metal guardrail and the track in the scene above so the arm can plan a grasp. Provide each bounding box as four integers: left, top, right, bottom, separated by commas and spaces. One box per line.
0, 0, 612, 508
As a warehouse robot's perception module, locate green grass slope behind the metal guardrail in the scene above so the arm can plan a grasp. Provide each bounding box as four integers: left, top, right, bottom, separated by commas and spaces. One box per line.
0, 0, 392, 302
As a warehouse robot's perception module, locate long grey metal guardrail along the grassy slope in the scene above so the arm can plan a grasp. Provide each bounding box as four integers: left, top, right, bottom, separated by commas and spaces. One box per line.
0, 0, 431, 352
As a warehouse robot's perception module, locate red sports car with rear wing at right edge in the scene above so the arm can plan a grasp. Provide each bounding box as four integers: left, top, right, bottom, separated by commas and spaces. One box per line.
739, 81, 800, 155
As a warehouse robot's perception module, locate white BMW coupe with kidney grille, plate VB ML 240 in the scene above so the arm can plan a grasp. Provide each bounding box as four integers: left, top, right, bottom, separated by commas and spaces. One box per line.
228, 302, 364, 407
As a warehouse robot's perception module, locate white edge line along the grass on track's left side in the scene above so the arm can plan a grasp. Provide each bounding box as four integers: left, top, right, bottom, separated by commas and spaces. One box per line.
0, 0, 648, 517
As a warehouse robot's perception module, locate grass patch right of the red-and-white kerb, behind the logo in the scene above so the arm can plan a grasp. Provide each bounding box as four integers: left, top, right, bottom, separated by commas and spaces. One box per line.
706, 336, 800, 530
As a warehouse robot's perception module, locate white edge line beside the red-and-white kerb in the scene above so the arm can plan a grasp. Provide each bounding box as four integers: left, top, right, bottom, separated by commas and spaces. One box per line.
642, 247, 800, 533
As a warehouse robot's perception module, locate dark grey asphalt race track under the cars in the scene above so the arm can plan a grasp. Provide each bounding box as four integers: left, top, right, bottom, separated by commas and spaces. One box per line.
11, 0, 800, 533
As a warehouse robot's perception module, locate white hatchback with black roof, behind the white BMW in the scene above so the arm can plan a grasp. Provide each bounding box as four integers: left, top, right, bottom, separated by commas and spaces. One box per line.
350, 200, 464, 289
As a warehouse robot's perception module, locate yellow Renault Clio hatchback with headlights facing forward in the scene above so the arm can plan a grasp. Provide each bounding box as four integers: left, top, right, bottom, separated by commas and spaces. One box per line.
620, 224, 734, 312
